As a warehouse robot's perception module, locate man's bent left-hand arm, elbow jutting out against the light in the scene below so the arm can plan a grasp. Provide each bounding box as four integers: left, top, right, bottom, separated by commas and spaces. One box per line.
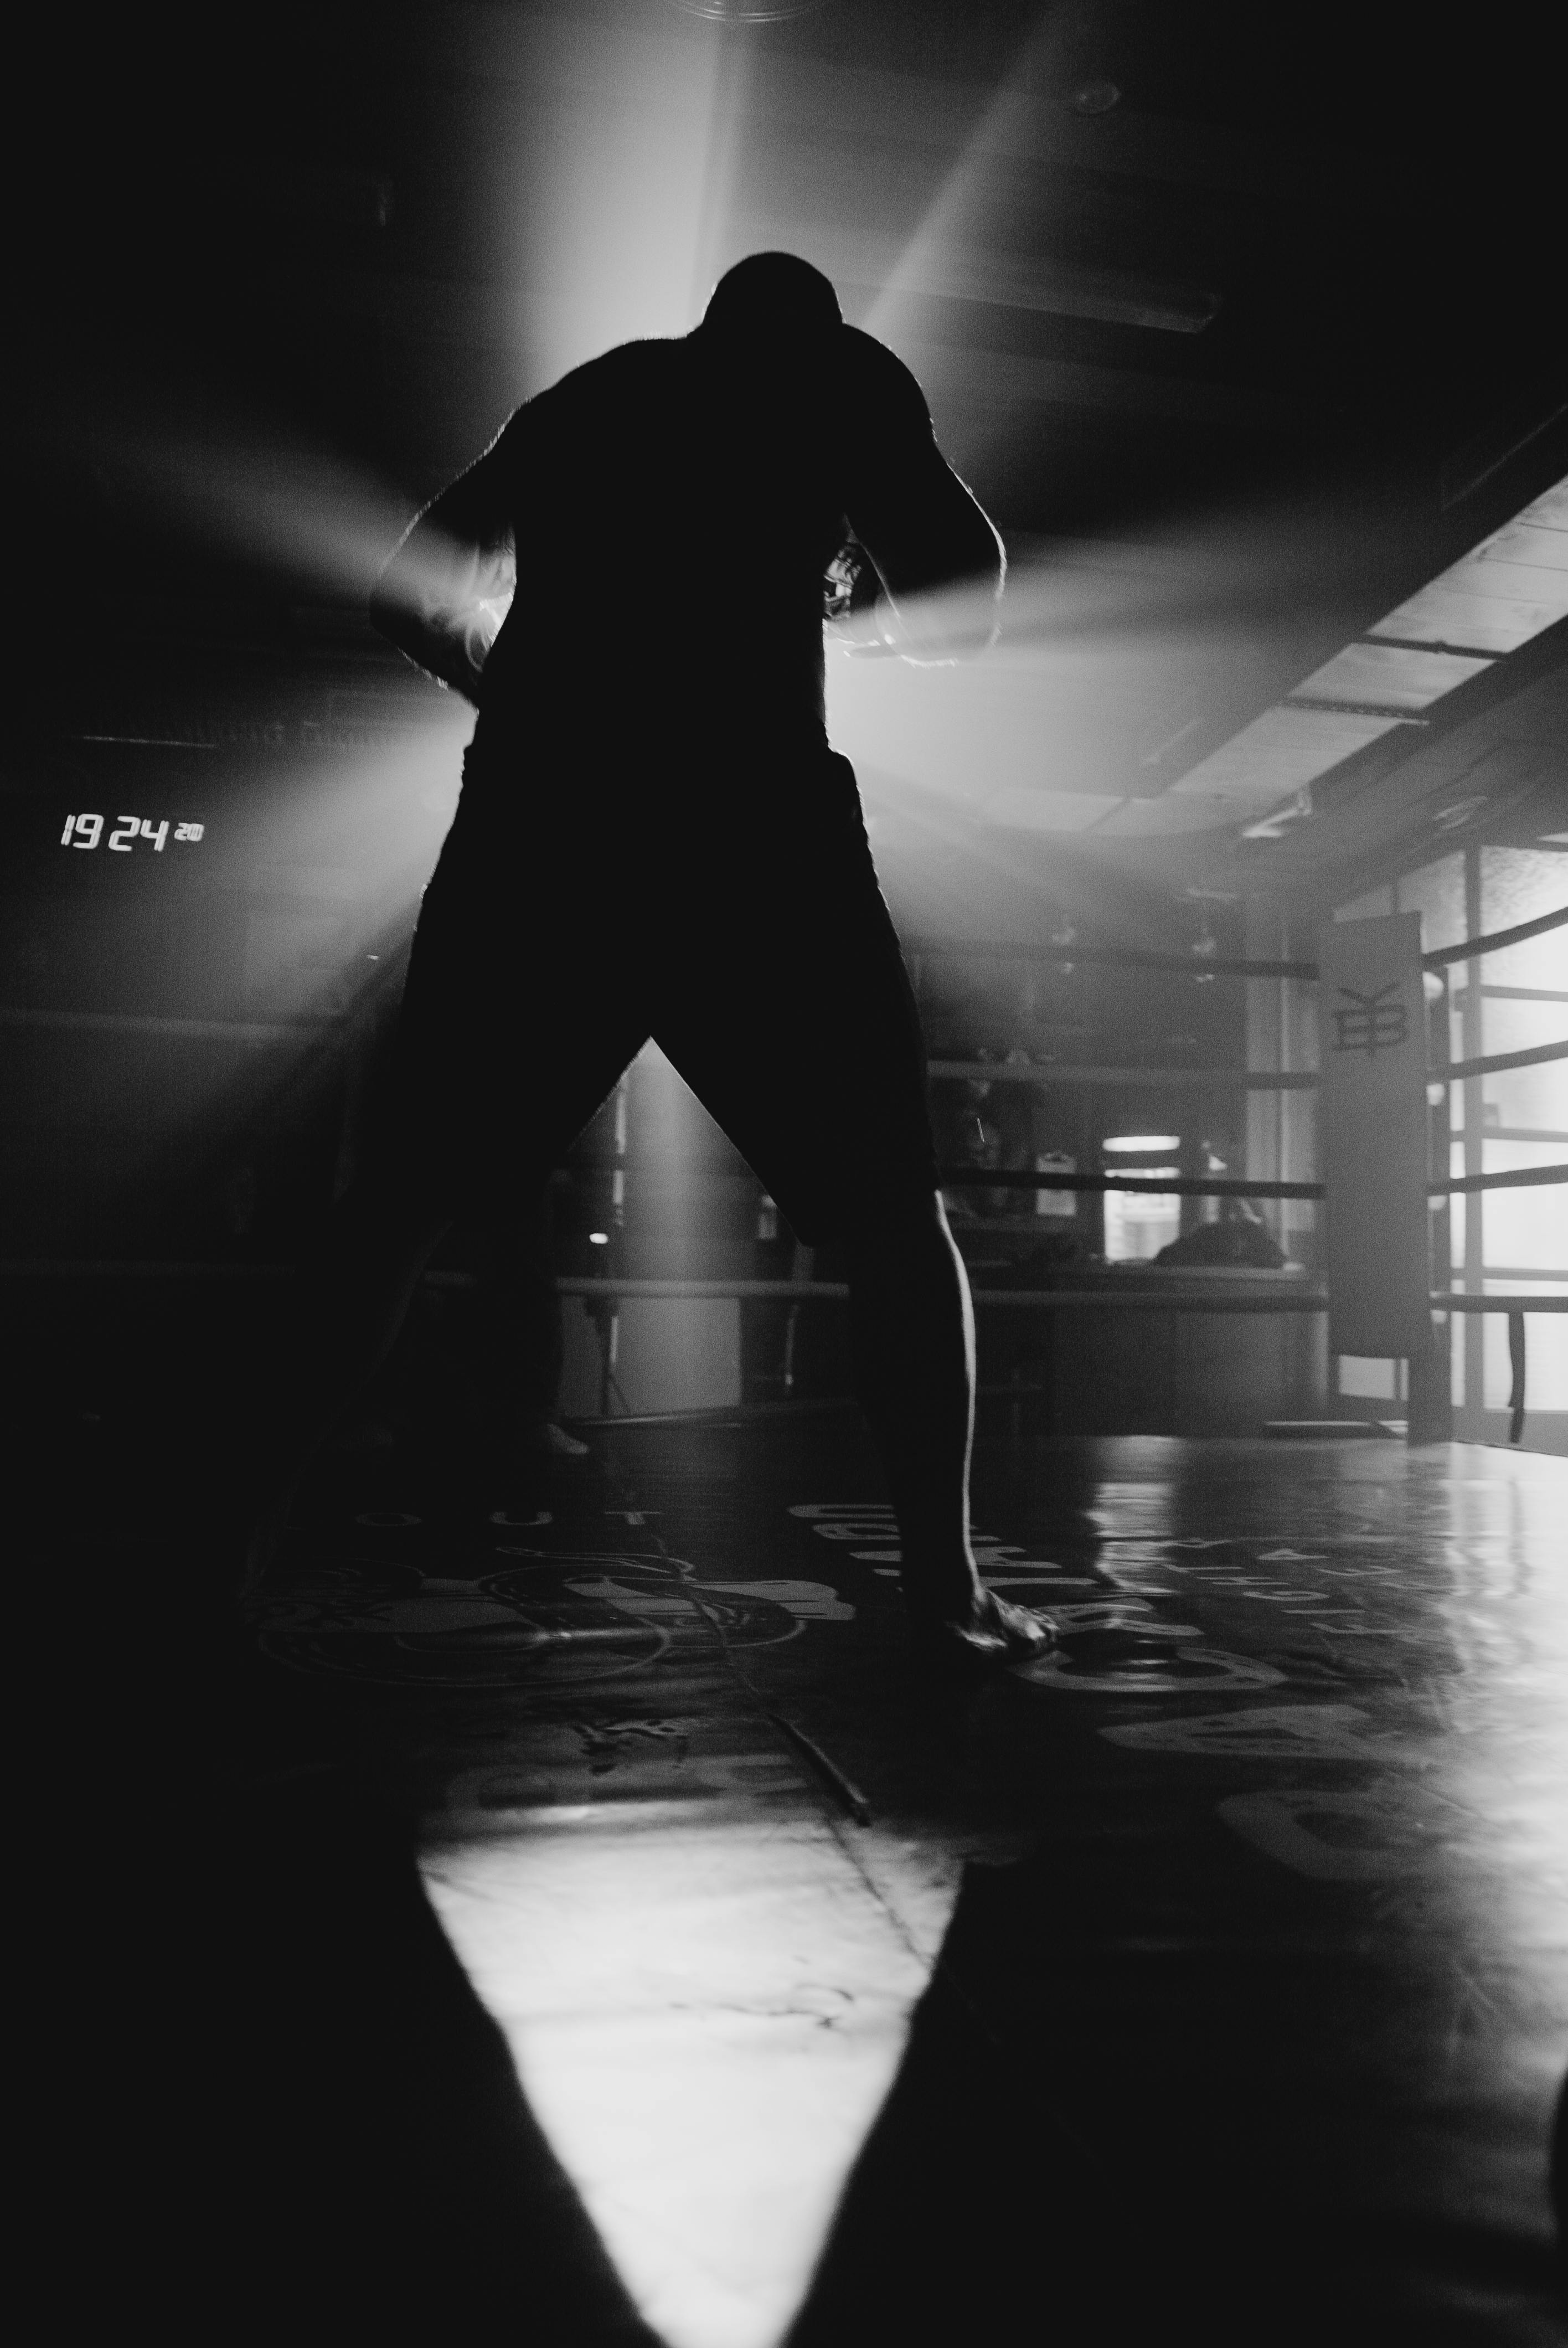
371, 418, 517, 702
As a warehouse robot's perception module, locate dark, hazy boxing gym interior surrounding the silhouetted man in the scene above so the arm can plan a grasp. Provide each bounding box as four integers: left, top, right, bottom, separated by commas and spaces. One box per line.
12, 0, 1568, 2348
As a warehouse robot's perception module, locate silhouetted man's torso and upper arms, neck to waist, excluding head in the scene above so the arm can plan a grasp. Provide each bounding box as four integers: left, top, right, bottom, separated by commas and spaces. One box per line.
385, 312, 1000, 765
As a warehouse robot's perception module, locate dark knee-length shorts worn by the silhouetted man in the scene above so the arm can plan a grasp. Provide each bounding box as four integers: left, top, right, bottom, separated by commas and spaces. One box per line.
390, 728, 937, 1244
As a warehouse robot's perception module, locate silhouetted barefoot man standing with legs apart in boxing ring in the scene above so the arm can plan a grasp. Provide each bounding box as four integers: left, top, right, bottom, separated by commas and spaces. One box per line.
282, 254, 1051, 1662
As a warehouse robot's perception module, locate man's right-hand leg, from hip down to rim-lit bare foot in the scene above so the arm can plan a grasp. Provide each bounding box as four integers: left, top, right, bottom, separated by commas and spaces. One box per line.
655, 759, 1051, 1662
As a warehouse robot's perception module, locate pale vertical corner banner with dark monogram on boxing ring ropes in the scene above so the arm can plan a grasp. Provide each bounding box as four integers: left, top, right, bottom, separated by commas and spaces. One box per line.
1317, 913, 1432, 1360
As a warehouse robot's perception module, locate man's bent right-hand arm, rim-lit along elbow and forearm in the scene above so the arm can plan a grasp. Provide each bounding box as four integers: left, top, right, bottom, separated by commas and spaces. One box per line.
845, 326, 1007, 660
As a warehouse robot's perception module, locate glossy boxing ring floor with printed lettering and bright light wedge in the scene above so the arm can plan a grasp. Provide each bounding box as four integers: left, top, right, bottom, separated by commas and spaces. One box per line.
28, 1411, 1568, 2348
